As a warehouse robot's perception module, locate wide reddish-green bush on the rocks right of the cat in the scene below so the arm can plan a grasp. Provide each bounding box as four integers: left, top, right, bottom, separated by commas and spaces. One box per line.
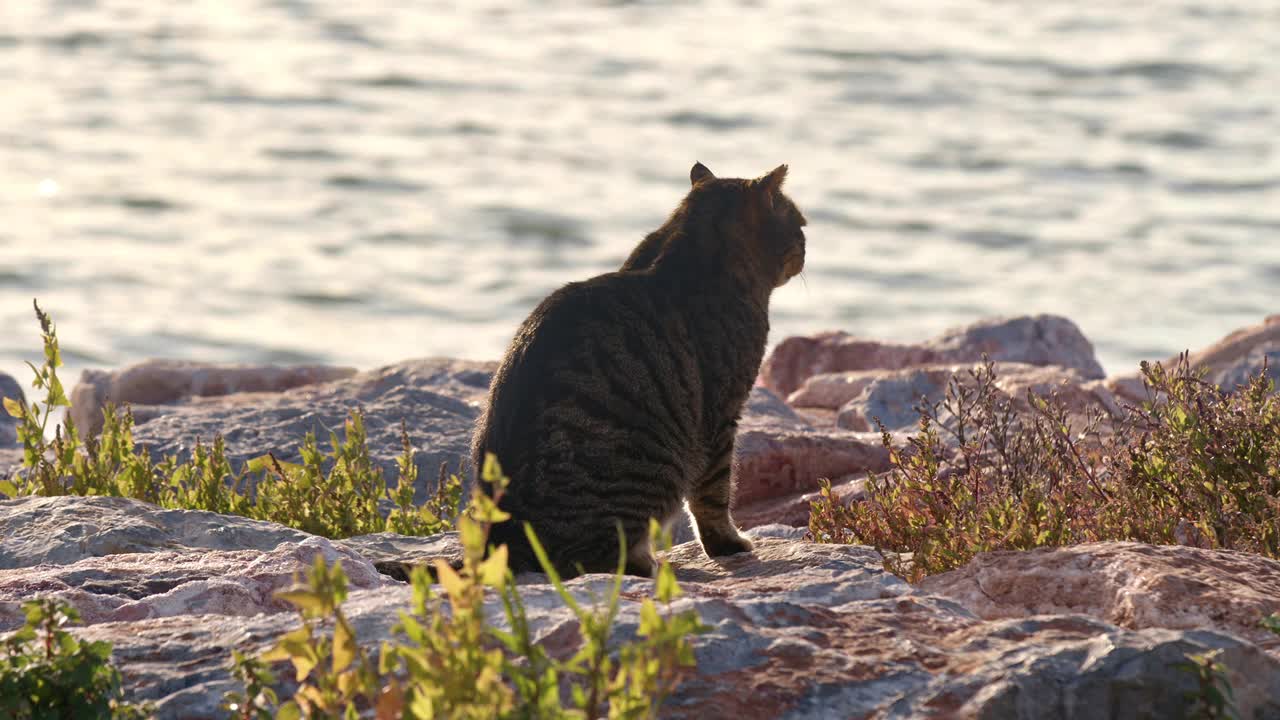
809, 357, 1280, 582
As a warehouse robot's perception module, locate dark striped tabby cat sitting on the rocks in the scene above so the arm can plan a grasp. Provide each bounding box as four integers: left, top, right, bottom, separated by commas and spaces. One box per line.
471, 163, 805, 577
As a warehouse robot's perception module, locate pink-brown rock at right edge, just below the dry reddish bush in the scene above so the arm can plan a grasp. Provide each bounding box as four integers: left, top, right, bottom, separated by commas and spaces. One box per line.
919, 542, 1280, 652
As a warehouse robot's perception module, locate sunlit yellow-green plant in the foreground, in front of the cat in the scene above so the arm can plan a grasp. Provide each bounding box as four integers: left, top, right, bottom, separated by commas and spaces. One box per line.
228, 457, 704, 720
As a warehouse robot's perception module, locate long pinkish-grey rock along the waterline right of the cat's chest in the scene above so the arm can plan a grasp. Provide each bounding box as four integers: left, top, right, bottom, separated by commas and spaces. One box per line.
760, 315, 1105, 396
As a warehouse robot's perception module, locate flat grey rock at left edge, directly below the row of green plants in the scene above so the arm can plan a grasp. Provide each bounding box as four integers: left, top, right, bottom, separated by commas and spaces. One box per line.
0, 496, 312, 570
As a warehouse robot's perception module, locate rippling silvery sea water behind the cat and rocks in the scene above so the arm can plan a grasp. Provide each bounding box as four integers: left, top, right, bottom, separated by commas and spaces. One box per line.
0, 0, 1280, 392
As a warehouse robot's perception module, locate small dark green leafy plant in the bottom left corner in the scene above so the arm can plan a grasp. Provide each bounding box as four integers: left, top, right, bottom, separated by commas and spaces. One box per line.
0, 598, 150, 720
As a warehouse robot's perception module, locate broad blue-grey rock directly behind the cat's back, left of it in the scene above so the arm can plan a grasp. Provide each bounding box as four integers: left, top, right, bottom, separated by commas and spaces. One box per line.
123, 359, 495, 501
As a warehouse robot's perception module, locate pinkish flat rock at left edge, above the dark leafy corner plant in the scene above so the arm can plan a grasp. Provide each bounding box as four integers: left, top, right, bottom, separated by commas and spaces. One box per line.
0, 537, 392, 630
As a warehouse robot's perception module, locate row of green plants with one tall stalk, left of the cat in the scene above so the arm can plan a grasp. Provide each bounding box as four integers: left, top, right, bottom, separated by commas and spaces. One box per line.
0, 297, 462, 538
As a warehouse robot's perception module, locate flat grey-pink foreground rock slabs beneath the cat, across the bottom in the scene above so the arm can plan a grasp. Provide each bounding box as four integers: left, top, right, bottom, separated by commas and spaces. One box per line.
0, 497, 1280, 720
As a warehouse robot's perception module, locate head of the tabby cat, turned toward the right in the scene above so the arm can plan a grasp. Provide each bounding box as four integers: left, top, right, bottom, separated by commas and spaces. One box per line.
685, 163, 805, 287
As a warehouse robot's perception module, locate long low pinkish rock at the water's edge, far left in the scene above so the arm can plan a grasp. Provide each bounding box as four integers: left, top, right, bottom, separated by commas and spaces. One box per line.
70, 360, 356, 436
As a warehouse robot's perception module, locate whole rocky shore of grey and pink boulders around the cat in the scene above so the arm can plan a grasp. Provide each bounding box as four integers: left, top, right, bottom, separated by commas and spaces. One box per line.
0, 315, 1280, 717
